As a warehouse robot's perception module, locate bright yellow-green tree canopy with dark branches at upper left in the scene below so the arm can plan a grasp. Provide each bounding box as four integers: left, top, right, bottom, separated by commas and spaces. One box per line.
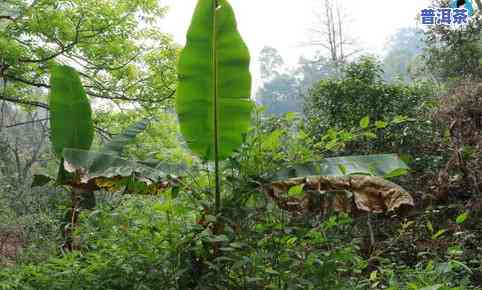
0, 0, 176, 114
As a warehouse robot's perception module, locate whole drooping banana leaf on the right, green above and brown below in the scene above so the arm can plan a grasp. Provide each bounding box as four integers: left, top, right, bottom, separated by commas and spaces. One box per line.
270, 154, 414, 214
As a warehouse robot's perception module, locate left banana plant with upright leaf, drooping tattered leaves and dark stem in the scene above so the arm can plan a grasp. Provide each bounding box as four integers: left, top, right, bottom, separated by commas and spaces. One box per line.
38, 65, 177, 250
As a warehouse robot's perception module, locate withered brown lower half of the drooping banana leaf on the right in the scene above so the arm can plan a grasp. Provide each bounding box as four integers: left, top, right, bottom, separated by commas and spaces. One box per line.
264, 175, 414, 216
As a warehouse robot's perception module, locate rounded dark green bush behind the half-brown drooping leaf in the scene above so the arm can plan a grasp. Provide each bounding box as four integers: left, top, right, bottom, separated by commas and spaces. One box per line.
305, 57, 433, 154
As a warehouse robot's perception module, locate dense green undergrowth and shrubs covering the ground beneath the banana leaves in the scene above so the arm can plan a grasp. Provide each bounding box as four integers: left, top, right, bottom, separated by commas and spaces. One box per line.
0, 93, 482, 289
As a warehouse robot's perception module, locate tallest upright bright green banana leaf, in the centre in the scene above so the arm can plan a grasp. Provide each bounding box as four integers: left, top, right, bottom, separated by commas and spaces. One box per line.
176, 0, 254, 160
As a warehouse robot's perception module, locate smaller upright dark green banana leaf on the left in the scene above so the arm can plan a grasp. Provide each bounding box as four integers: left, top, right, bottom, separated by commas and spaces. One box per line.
49, 65, 94, 158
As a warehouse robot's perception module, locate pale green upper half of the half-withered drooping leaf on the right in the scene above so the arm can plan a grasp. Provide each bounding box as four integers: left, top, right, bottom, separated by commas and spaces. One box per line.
276, 154, 409, 180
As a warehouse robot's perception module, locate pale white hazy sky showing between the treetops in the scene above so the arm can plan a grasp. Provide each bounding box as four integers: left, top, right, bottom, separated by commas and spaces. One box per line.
159, 0, 429, 84
